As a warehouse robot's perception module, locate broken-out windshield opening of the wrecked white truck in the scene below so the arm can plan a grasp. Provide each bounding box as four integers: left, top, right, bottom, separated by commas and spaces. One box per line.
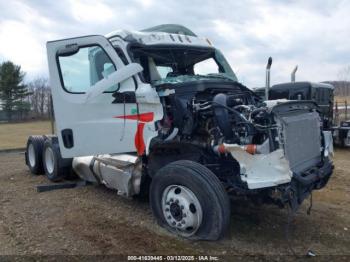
130, 46, 237, 84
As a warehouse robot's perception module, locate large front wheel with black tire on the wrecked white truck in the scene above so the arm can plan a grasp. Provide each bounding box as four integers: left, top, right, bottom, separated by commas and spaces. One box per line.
150, 160, 230, 240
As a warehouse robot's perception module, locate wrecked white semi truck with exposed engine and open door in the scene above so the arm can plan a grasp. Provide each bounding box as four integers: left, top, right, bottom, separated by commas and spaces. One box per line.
26, 25, 333, 240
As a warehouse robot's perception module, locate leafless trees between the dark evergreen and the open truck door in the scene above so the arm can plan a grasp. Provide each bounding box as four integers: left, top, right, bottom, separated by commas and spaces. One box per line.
28, 77, 51, 118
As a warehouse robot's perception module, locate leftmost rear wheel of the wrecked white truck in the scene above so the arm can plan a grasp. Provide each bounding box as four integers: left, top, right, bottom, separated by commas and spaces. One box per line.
25, 136, 44, 175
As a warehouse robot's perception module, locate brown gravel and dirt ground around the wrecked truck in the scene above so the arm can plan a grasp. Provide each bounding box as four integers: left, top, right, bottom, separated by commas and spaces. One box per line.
0, 150, 350, 260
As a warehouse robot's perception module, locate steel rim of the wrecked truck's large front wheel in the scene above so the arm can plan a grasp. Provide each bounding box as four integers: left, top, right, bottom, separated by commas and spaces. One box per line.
162, 185, 203, 237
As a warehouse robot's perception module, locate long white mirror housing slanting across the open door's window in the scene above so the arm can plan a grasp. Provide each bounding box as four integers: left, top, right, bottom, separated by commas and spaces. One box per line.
85, 63, 143, 102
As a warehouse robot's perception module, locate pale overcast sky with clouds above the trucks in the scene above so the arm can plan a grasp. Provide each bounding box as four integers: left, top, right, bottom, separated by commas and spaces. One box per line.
0, 0, 350, 87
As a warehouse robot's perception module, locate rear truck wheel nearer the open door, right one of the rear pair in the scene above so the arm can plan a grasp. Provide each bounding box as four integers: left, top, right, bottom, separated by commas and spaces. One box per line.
43, 136, 72, 182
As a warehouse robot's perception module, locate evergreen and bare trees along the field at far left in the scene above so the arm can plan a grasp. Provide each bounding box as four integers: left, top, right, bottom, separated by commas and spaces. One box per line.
0, 61, 51, 121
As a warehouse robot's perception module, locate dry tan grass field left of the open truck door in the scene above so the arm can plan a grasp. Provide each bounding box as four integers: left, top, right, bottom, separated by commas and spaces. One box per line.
0, 121, 51, 150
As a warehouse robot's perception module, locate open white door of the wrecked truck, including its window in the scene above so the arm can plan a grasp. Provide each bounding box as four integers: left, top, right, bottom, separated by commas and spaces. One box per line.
47, 36, 142, 158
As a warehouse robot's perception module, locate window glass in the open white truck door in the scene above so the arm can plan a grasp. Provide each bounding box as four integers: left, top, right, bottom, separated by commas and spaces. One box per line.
58, 45, 117, 94
